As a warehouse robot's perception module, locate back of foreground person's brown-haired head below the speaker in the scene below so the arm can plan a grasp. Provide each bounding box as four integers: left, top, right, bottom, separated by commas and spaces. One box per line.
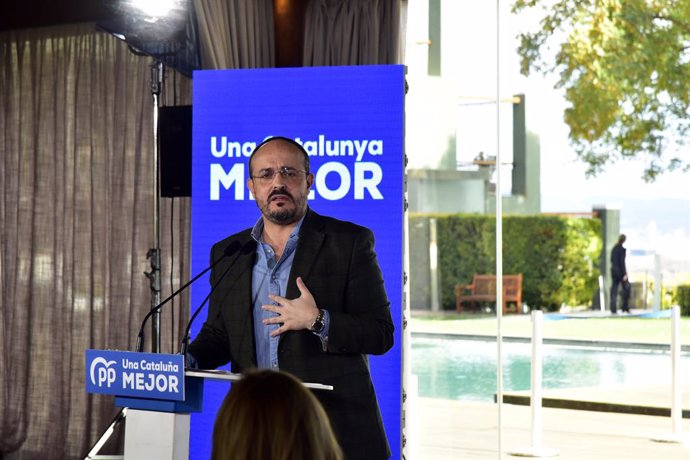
211, 369, 343, 460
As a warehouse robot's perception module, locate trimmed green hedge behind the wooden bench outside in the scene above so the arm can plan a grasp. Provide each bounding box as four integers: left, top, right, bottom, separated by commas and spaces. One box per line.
410, 214, 602, 310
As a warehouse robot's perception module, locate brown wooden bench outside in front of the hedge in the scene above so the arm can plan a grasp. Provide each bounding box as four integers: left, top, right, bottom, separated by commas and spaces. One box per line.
455, 273, 522, 314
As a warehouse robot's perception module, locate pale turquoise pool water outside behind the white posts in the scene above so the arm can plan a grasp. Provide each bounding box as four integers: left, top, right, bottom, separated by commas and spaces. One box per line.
411, 338, 690, 401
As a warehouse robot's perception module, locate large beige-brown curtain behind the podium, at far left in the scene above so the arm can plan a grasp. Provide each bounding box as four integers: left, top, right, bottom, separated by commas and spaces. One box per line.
0, 24, 191, 460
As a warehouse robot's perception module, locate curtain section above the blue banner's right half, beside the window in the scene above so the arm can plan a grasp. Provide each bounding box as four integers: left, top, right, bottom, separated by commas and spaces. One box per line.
303, 0, 403, 66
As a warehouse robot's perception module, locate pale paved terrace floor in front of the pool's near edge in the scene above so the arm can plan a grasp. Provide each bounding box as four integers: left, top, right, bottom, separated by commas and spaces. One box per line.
411, 398, 690, 460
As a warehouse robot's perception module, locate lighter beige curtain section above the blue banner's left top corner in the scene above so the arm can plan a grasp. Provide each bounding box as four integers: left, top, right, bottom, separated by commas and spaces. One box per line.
194, 0, 275, 69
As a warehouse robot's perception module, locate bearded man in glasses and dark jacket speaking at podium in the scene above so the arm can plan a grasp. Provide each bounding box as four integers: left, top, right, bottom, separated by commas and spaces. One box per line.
189, 137, 394, 460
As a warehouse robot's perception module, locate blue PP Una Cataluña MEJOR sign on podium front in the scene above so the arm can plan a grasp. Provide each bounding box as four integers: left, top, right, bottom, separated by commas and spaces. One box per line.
86, 350, 185, 401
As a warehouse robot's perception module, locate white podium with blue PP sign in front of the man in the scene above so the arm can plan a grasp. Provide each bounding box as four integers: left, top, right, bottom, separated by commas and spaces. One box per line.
86, 350, 333, 460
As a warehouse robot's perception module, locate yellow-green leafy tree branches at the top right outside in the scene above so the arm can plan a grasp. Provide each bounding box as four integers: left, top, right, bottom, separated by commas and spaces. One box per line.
512, 0, 690, 181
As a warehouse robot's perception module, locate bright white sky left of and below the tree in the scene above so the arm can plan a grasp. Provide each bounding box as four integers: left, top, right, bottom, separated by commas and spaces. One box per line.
406, 0, 690, 272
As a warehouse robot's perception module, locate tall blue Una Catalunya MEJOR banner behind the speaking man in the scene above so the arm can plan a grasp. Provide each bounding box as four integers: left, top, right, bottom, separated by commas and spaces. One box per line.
190, 66, 405, 459
